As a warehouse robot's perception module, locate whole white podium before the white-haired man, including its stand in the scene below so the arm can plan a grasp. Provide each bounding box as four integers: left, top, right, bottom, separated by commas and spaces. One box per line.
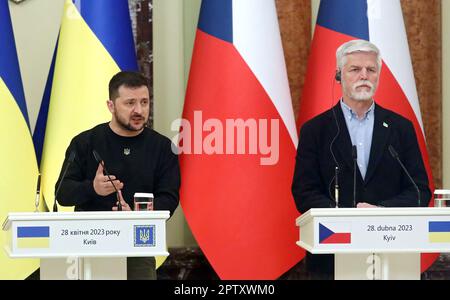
296, 207, 450, 279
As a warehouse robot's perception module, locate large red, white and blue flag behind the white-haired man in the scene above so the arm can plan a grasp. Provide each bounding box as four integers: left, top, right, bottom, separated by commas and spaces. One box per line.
297, 0, 436, 270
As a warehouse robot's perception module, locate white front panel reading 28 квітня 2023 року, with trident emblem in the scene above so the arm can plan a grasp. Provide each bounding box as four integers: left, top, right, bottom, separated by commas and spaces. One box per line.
4, 211, 168, 257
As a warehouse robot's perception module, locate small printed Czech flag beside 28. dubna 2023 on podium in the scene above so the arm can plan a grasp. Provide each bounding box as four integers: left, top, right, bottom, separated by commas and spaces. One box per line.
319, 222, 352, 244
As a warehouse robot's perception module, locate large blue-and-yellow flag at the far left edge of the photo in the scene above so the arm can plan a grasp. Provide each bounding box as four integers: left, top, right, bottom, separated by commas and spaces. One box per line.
0, 1, 39, 279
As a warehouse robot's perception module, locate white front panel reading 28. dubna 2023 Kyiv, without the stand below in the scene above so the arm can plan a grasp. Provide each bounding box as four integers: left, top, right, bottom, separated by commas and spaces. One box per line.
298, 208, 450, 253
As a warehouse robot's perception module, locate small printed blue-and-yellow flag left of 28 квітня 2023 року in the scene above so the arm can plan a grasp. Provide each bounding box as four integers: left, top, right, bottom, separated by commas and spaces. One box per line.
16, 226, 50, 248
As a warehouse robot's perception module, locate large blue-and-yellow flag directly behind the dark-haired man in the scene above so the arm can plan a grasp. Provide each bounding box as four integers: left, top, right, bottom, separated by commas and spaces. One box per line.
41, 0, 137, 213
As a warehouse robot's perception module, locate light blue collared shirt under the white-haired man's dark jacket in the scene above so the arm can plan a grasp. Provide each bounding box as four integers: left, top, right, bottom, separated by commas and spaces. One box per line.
341, 99, 375, 179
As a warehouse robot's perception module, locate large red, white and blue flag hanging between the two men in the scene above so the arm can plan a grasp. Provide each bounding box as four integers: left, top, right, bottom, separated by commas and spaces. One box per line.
179, 0, 304, 279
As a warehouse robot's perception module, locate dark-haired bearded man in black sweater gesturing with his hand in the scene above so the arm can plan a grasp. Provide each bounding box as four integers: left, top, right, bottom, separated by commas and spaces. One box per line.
56, 72, 180, 279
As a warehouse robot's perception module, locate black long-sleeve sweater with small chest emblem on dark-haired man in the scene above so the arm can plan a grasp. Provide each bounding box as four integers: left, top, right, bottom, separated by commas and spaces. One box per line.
56, 123, 180, 215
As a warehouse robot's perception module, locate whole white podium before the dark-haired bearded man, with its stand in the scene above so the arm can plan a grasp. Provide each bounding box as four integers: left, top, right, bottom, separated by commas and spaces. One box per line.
3, 211, 170, 279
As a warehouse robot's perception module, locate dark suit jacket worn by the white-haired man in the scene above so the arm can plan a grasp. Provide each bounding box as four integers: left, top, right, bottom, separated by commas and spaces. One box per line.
292, 103, 431, 213
